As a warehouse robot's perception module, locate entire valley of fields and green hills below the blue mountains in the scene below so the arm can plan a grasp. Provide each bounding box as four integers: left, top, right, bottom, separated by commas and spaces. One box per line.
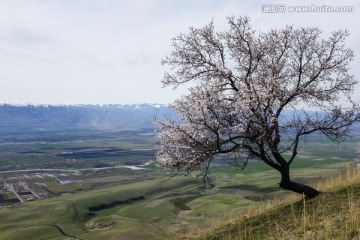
0, 126, 359, 239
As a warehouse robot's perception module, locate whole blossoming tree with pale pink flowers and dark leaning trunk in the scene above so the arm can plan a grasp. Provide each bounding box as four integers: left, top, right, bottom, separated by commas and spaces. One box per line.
157, 17, 360, 197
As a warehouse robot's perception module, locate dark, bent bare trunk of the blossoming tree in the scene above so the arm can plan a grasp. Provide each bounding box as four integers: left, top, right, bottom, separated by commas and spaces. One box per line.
279, 167, 320, 198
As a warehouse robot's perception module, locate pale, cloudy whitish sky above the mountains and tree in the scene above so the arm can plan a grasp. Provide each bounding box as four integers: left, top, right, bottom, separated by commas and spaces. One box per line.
0, 0, 360, 104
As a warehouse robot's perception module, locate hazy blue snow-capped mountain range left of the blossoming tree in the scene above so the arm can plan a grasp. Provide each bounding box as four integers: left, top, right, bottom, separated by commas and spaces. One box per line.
0, 104, 175, 130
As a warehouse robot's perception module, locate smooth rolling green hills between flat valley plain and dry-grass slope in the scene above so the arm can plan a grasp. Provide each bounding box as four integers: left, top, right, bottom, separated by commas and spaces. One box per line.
0, 161, 349, 239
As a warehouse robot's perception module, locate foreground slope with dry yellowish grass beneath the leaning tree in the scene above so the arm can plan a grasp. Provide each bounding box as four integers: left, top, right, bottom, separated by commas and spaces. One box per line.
197, 166, 360, 239
